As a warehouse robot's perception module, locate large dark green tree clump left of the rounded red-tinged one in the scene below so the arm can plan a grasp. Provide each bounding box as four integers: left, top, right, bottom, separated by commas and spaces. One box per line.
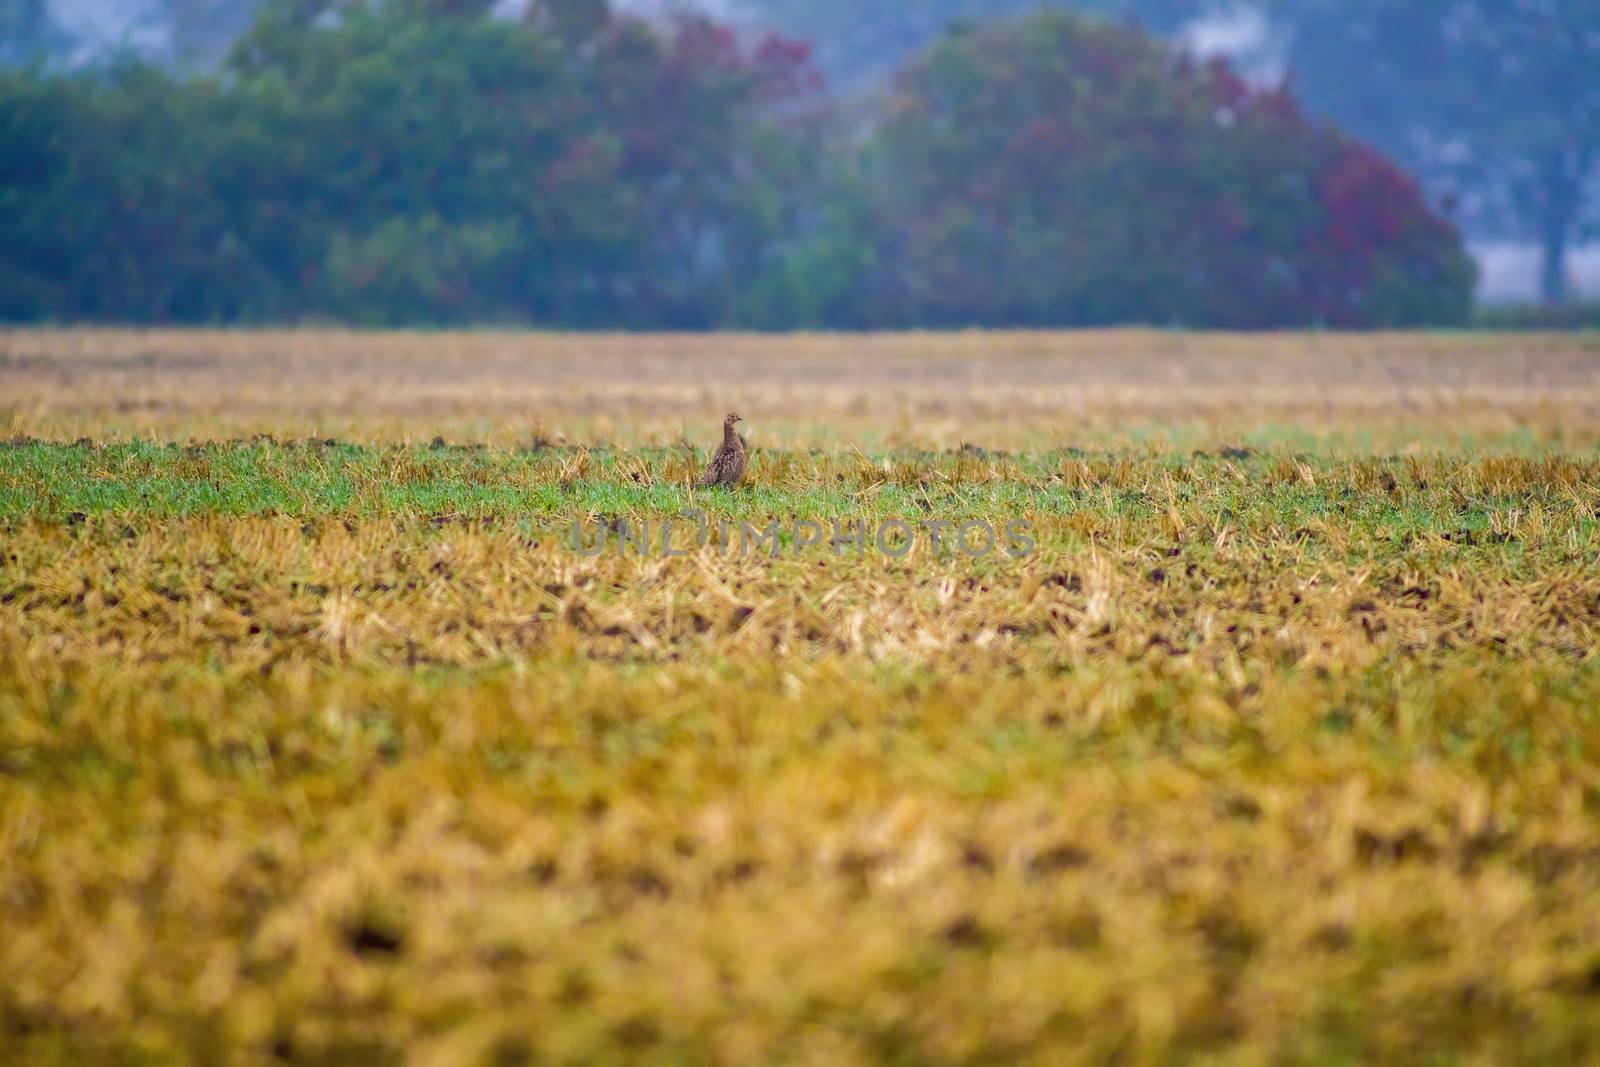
0, 0, 827, 328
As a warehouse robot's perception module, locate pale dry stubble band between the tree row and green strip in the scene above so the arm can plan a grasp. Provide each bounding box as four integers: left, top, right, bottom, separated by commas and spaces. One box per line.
0, 323, 1600, 448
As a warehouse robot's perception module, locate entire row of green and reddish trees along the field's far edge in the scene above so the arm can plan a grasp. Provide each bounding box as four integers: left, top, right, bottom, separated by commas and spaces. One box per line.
0, 0, 1474, 330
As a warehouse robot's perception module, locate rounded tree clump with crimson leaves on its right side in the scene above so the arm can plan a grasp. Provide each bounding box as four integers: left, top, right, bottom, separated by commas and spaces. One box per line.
869, 13, 1474, 328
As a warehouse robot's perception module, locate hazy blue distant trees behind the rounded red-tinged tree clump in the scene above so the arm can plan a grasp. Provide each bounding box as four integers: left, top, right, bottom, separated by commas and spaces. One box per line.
739, 0, 1600, 304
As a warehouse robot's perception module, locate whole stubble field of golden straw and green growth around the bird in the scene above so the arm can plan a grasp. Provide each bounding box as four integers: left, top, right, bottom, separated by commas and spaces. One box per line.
0, 331, 1600, 1065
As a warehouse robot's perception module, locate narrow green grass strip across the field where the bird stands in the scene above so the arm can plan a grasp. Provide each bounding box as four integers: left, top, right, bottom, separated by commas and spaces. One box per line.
0, 442, 1600, 544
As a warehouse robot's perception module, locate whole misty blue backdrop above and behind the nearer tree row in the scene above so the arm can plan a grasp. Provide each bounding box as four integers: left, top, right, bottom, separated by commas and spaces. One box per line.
0, 0, 1600, 321
